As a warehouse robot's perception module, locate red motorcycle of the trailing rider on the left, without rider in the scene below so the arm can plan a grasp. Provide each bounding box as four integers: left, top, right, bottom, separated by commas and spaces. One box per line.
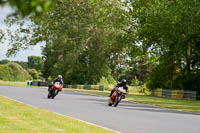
47, 82, 62, 99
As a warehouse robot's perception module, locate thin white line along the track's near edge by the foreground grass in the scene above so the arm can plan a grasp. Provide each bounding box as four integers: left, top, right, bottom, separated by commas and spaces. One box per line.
0, 95, 121, 133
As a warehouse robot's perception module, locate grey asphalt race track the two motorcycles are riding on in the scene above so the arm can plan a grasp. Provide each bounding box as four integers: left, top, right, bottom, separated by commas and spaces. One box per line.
0, 86, 200, 133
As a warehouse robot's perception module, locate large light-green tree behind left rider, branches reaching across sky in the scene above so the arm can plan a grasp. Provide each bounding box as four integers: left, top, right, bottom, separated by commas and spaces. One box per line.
3, 0, 131, 84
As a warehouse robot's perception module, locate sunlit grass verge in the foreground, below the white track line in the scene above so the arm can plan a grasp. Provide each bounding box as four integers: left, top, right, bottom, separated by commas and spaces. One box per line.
0, 96, 112, 133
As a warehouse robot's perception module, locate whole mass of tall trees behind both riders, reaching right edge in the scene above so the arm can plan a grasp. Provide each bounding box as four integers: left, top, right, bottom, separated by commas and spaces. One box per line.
0, 0, 200, 90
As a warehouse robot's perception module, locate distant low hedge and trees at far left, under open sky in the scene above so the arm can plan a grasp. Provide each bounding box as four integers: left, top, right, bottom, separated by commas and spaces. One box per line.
0, 56, 44, 81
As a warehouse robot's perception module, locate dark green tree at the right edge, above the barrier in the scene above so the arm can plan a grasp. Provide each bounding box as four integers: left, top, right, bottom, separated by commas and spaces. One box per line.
129, 0, 200, 90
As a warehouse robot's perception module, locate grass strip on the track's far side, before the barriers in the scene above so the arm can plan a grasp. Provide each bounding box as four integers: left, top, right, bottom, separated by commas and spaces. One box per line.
64, 88, 200, 113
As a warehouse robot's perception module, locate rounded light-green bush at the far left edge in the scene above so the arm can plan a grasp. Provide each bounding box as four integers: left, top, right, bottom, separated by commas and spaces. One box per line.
0, 62, 32, 81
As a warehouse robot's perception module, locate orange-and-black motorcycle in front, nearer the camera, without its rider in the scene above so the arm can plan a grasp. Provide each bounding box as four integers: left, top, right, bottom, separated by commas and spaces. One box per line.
108, 88, 126, 107
